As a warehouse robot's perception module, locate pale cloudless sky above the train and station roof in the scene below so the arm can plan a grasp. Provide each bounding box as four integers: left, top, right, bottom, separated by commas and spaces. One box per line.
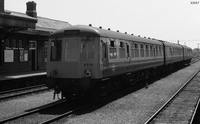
5, 0, 200, 48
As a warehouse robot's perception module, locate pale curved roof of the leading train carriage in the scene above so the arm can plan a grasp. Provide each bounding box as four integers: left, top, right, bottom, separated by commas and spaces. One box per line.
53, 25, 162, 45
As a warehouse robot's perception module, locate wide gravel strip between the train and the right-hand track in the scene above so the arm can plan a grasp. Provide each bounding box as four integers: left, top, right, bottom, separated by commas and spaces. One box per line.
56, 62, 200, 124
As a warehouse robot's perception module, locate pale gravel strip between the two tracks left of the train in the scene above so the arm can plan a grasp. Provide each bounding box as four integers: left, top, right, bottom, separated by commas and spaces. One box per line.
0, 91, 57, 120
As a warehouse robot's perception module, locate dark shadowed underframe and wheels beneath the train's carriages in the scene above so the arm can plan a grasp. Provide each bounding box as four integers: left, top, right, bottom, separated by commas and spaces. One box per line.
48, 60, 190, 98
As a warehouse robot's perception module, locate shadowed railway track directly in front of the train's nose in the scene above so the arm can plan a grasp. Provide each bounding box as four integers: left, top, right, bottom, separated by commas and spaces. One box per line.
0, 99, 88, 124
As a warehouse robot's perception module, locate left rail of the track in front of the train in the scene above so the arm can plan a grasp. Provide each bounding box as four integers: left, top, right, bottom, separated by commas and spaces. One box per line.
0, 100, 66, 124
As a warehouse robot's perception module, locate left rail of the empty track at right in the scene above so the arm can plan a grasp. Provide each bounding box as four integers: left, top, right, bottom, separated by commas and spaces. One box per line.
144, 70, 200, 124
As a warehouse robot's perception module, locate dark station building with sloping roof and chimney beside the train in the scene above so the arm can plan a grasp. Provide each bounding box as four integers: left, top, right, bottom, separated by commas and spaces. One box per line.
0, 0, 71, 75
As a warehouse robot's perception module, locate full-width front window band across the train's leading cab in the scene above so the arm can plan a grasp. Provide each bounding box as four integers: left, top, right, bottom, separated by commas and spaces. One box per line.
50, 36, 96, 62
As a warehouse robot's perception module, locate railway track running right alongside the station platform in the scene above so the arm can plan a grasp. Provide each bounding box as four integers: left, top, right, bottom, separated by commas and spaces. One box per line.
0, 84, 49, 101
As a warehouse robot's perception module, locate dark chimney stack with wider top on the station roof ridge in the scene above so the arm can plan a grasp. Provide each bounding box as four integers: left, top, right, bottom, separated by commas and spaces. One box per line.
26, 1, 37, 18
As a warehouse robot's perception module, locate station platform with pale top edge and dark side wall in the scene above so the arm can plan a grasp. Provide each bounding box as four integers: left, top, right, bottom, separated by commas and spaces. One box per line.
0, 71, 47, 91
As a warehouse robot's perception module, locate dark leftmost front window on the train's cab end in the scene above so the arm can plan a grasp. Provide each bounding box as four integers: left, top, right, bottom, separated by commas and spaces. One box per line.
50, 40, 62, 61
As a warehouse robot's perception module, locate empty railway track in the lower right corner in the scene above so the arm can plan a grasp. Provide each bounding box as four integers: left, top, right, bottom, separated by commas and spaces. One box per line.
145, 71, 200, 124
